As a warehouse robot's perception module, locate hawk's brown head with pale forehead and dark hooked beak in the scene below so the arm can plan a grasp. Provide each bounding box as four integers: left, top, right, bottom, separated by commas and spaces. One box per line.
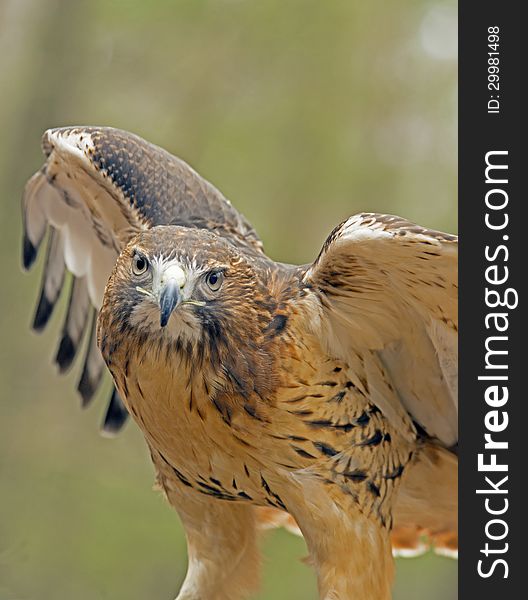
105, 226, 265, 341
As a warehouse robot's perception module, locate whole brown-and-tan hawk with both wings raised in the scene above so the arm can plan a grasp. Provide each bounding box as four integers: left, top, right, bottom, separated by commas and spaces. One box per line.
23, 127, 458, 600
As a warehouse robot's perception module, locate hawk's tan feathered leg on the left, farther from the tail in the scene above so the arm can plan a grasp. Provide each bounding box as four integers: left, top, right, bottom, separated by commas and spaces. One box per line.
159, 474, 259, 600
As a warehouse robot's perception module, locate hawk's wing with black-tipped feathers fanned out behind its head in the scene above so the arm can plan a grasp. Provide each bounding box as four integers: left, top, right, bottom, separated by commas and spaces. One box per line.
23, 127, 262, 432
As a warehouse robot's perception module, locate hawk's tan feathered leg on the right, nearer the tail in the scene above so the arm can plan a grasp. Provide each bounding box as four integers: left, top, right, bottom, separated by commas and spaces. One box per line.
286, 482, 394, 600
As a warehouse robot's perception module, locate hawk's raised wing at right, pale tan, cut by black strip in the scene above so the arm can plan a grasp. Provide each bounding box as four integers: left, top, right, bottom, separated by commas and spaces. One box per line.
304, 214, 458, 447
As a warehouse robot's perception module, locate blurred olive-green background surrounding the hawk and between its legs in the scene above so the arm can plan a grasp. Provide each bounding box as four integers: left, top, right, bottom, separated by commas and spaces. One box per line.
0, 0, 457, 600
